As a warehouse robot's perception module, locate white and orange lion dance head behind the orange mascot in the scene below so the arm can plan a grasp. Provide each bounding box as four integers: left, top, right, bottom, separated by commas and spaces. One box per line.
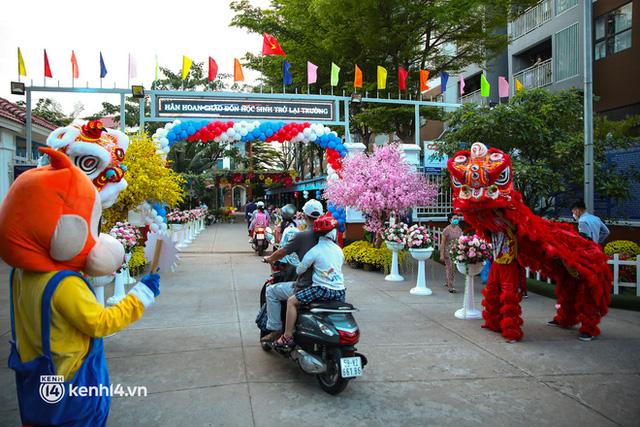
42, 120, 129, 208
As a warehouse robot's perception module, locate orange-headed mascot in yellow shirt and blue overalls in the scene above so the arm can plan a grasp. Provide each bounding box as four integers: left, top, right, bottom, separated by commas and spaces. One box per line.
0, 148, 160, 426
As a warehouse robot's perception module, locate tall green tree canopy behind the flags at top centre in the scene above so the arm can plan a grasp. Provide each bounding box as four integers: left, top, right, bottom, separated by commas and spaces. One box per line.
231, 0, 537, 146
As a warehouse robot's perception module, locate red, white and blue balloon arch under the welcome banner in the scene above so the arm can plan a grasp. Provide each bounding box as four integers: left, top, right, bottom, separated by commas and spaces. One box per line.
153, 120, 348, 232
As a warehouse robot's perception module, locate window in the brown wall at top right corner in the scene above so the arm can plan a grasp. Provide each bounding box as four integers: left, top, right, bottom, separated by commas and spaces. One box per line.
595, 3, 631, 61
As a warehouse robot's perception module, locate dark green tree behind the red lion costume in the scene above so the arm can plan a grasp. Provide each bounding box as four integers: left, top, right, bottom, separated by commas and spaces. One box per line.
441, 89, 640, 213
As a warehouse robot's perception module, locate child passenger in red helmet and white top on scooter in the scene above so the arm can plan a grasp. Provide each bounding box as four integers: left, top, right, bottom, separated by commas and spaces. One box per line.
274, 214, 345, 347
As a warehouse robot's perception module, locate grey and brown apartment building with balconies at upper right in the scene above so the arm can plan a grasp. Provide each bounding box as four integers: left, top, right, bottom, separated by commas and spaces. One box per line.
447, 0, 640, 119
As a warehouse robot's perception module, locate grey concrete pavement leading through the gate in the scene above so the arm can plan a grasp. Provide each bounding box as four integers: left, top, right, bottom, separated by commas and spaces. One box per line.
0, 224, 640, 426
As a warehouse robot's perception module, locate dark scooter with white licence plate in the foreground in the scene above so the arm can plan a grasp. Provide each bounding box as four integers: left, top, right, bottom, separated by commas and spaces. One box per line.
256, 265, 368, 395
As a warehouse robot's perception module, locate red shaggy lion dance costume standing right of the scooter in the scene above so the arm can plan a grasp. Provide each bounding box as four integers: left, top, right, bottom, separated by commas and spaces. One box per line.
447, 142, 612, 342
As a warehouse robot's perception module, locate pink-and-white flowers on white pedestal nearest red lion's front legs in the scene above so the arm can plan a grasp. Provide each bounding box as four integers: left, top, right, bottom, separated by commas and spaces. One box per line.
449, 234, 491, 320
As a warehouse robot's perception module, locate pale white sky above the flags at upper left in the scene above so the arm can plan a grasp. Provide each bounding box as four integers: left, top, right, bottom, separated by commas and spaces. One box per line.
0, 0, 270, 115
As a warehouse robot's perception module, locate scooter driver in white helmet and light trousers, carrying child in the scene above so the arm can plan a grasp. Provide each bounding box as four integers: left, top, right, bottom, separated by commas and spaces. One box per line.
261, 199, 324, 342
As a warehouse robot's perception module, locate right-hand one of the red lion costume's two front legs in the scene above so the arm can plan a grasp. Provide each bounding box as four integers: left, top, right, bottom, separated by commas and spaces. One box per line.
498, 262, 523, 341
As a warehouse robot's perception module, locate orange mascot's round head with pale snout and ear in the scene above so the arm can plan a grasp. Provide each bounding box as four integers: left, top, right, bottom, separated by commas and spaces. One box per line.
0, 148, 124, 276
